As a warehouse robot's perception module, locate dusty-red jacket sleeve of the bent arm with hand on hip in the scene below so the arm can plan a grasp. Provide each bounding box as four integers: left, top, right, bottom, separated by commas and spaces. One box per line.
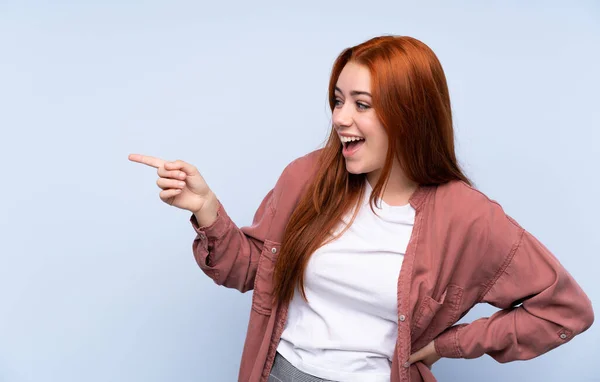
434, 210, 594, 363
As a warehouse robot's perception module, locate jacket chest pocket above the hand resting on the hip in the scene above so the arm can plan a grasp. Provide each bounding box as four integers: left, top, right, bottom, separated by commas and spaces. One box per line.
411, 284, 463, 341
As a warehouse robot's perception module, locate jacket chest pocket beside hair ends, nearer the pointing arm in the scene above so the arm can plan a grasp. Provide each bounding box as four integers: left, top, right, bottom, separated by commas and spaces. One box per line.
252, 240, 281, 315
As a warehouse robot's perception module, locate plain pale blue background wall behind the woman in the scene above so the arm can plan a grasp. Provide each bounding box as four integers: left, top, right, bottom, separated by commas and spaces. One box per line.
0, 0, 600, 382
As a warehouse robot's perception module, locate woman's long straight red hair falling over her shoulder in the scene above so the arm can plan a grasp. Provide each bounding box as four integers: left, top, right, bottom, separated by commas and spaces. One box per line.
273, 36, 471, 304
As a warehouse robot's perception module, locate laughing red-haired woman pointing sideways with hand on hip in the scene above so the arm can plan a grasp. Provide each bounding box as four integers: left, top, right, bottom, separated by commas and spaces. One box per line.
130, 36, 594, 382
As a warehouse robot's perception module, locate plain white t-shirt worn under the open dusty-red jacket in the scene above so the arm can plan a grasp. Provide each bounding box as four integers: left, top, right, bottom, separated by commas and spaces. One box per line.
277, 181, 415, 382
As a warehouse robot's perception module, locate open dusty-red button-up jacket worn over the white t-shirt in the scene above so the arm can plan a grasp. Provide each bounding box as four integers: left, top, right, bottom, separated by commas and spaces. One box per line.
190, 150, 594, 382
